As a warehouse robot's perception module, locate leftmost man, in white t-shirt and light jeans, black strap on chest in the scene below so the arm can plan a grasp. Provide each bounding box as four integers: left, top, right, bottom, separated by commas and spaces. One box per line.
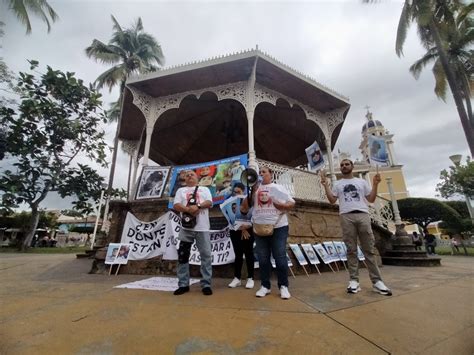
173, 170, 212, 296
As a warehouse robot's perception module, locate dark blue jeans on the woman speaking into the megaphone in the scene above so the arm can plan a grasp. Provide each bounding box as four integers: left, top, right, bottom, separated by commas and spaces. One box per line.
255, 226, 288, 289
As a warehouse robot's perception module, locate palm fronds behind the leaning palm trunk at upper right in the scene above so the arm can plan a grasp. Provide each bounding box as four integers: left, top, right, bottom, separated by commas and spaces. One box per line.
410, 3, 474, 123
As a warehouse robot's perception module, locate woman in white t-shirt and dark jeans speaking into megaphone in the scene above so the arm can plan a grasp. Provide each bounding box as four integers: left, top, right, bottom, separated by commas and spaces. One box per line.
240, 167, 295, 299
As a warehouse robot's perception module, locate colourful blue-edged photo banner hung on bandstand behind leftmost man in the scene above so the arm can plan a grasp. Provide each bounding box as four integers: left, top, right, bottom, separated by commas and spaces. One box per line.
168, 154, 247, 208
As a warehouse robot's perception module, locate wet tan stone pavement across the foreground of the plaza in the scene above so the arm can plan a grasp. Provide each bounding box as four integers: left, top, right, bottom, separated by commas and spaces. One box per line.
0, 254, 474, 355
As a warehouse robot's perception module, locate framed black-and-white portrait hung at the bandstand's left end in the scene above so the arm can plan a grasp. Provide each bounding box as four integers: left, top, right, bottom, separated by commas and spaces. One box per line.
135, 166, 170, 200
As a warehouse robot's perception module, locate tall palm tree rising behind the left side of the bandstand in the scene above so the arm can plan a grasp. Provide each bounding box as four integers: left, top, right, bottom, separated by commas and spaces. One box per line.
85, 16, 164, 204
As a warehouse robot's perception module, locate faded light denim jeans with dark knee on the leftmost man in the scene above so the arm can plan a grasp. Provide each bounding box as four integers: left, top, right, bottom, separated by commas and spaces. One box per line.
177, 228, 212, 288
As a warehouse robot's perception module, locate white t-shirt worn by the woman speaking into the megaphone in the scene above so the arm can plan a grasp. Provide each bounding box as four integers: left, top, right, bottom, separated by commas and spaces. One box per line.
252, 182, 295, 228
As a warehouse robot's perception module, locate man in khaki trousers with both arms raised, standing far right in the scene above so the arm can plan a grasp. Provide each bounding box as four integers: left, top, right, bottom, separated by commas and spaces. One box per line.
321, 159, 392, 296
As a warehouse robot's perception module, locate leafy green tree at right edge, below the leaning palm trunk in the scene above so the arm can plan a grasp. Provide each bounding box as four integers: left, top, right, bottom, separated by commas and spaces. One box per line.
436, 157, 474, 199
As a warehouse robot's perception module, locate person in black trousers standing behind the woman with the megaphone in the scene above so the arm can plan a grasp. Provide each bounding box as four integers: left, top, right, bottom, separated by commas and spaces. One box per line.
229, 182, 255, 289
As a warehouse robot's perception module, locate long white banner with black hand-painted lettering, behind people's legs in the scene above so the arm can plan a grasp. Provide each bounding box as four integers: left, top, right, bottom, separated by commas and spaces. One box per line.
120, 211, 235, 265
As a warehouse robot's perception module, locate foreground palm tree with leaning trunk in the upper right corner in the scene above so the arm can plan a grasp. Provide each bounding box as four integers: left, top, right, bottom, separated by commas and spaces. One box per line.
362, 0, 474, 155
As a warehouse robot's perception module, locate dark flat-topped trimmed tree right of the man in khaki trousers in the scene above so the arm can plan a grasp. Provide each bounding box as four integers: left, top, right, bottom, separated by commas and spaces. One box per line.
397, 198, 461, 230
